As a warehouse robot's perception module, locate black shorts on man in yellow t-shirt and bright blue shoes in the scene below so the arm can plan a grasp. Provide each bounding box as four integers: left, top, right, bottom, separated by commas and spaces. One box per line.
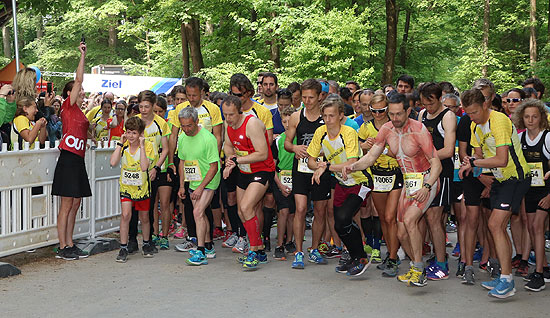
490, 177, 531, 215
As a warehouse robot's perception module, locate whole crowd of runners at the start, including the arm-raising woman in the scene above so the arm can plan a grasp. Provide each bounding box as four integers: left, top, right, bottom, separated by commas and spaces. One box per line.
4, 44, 550, 298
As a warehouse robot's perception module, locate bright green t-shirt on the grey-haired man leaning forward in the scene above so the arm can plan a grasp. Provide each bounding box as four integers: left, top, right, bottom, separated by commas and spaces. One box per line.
178, 128, 220, 190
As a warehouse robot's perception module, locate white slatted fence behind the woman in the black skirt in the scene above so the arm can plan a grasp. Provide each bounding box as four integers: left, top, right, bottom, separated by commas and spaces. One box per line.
0, 142, 120, 257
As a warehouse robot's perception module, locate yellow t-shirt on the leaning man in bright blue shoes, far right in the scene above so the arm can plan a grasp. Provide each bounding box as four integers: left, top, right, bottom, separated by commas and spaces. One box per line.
470, 111, 531, 181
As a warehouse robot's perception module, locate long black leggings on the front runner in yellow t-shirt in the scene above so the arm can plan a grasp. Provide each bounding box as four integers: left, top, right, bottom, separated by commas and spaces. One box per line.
334, 194, 367, 259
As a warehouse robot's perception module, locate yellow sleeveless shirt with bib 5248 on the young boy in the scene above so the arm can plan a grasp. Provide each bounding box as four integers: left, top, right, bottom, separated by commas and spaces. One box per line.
119, 140, 158, 201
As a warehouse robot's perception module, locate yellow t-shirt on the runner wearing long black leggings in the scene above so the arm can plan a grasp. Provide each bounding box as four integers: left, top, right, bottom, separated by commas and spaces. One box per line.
307, 125, 369, 186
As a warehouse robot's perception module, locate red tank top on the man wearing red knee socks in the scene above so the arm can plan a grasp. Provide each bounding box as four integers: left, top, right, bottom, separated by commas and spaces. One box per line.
227, 115, 275, 174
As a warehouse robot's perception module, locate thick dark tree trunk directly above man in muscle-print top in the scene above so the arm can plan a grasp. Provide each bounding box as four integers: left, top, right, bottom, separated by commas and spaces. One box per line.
382, 0, 397, 85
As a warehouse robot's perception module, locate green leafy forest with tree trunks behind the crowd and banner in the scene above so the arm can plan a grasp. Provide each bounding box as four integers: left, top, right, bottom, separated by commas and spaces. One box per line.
0, 0, 550, 95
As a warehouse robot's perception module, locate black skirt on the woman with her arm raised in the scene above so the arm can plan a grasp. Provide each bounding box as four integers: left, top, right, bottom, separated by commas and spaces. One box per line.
52, 150, 92, 198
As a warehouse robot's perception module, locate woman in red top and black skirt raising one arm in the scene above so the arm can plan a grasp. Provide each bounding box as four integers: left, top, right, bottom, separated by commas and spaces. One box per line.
52, 43, 92, 260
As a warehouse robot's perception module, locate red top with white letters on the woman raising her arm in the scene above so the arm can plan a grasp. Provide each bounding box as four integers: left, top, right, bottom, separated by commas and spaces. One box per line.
59, 97, 90, 157
